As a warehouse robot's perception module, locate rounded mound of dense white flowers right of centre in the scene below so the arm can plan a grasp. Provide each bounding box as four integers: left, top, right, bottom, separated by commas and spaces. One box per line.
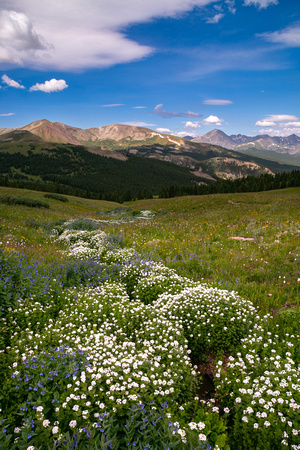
153, 283, 260, 352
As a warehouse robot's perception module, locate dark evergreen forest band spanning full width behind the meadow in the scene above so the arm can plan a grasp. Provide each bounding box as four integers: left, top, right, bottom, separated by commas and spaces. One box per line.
0, 144, 300, 203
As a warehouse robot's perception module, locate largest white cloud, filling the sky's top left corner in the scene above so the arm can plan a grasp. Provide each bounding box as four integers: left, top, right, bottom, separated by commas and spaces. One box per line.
0, 0, 215, 70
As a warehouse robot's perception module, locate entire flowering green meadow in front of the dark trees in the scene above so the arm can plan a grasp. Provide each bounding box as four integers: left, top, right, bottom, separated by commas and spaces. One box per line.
0, 187, 300, 450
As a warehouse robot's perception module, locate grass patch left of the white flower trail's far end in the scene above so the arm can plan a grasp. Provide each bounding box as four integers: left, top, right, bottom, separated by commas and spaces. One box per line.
0, 187, 119, 262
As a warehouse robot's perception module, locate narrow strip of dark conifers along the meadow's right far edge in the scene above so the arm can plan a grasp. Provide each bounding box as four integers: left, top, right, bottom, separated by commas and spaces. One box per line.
159, 170, 300, 198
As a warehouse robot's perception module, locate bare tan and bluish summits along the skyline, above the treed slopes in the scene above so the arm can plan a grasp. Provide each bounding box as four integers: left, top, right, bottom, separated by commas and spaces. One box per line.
0, 119, 300, 162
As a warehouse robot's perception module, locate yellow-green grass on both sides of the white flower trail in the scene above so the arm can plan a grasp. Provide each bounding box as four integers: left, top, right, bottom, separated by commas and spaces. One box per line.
0, 188, 300, 311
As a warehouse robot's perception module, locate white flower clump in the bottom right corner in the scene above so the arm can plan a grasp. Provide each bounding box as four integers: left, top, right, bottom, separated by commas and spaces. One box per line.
217, 326, 300, 449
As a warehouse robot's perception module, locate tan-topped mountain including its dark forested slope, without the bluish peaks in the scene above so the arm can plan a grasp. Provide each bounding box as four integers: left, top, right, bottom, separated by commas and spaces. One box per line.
0, 120, 298, 196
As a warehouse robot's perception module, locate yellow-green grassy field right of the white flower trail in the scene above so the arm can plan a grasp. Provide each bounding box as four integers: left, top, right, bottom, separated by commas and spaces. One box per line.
118, 188, 300, 311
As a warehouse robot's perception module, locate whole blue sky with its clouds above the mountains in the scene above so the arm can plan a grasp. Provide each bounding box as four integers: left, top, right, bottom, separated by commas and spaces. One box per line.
0, 0, 300, 136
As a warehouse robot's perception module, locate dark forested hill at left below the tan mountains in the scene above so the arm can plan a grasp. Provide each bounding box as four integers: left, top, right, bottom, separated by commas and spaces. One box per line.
0, 144, 197, 203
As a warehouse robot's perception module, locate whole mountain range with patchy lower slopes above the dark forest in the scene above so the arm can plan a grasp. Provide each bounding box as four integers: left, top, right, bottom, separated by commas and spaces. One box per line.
0, 119, 300, 190
